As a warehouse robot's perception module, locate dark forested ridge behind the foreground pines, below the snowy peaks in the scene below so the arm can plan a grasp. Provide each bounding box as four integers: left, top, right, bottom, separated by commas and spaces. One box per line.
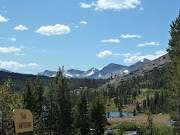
0, 71, 109, 91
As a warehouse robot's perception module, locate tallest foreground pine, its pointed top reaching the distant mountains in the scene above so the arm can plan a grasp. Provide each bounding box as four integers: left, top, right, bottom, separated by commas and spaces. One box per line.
54, 68, 73, 135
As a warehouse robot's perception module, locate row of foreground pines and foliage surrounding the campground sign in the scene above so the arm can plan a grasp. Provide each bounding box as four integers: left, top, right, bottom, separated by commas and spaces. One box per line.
0, 69, 106, 135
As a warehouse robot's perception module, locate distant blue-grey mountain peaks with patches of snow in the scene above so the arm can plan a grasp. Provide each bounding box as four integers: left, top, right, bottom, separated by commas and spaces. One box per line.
40, 59, 150, 79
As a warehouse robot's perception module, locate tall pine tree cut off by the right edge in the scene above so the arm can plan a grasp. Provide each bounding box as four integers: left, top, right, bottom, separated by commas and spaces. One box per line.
167, 14, 180, 134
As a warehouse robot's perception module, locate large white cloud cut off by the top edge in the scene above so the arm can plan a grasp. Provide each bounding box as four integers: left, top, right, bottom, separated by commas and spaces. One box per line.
81, 0, 141, 11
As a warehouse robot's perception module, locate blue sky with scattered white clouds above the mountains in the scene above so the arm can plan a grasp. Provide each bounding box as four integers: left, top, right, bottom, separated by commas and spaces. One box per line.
0, 0, 180, 74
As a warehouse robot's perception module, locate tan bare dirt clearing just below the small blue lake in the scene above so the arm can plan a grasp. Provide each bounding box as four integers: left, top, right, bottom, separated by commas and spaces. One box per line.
107, 114, 170, 126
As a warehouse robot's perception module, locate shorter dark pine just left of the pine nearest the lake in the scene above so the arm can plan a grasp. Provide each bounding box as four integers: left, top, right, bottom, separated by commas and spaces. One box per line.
75, 91, 89, 135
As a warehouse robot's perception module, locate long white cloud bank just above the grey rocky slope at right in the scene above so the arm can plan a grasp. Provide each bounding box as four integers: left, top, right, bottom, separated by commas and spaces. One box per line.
124, 50, 167, 63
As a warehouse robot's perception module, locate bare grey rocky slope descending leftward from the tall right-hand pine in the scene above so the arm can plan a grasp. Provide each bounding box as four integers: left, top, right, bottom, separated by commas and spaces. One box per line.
108, 54, 171, 84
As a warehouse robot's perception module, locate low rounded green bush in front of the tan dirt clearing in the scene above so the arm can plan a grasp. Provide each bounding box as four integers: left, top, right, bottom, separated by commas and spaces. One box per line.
116, 122, 138, 131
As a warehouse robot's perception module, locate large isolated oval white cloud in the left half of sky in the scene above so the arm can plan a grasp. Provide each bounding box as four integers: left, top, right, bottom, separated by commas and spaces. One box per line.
35, 24, 71, 36
